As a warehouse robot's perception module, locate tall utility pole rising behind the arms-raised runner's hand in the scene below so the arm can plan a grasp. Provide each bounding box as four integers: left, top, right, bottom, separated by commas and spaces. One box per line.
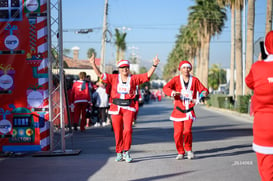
100, 0, 108, 72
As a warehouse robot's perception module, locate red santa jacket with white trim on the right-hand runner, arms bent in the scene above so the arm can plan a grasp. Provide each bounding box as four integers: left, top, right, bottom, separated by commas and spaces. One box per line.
163, 75, 208, 121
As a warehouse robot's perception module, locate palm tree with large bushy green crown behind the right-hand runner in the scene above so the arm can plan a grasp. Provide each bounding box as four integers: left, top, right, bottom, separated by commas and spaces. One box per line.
188, 0, 226, 86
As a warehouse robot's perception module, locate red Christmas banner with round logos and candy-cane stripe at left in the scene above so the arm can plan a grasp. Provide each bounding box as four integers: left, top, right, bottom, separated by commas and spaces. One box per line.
0, 0, 49, 151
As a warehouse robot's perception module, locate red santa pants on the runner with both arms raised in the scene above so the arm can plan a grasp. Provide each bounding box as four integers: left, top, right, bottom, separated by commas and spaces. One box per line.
112, 108, 135, 153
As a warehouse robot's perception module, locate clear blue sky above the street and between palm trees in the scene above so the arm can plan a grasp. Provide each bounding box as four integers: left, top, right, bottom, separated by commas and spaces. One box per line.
63, 0, 266, 72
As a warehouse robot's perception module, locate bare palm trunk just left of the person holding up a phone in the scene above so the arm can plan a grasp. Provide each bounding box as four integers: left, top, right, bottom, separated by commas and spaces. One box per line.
244, 0, 255, 95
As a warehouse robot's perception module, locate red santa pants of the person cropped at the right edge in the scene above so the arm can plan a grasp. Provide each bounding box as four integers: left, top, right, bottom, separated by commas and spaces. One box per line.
256, 152, 273, 181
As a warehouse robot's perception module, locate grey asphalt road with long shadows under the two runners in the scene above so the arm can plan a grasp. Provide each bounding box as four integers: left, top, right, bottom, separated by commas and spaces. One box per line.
0, 99, 260, 181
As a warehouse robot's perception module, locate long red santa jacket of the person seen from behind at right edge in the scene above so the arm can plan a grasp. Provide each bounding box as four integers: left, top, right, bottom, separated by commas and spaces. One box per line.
245, 58, 273, 154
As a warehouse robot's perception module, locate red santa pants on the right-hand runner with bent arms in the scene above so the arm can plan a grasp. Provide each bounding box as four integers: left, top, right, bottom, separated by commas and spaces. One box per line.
173, 120, 192, 155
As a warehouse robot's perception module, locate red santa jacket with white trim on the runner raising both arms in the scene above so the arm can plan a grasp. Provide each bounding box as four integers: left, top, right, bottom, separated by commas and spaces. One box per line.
101, 73, 150, 114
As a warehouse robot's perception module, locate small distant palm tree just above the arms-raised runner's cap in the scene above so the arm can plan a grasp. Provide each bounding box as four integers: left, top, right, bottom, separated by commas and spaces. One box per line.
115, 29, 126, 62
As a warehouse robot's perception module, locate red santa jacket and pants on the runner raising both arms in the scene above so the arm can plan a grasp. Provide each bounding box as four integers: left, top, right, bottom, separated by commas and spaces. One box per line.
101, 73, 149, 153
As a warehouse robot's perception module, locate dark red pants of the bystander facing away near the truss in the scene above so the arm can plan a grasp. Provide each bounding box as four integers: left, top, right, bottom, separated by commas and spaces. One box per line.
74, 102, 88, 131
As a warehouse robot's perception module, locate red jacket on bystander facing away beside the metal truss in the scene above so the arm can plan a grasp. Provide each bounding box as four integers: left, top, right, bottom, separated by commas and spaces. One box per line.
71, 80, 91, 104
